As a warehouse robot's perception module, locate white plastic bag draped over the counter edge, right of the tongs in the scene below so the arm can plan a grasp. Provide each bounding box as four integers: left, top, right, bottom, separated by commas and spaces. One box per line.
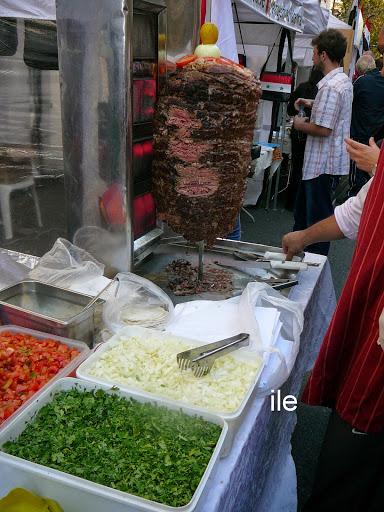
239, 283, 304, 394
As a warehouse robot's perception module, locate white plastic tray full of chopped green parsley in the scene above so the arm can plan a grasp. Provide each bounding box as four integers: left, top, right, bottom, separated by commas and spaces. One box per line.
0, 378, 227, 510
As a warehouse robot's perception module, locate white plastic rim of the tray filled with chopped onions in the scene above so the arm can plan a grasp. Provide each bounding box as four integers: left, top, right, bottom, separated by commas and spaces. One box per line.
76, 326, 265, 457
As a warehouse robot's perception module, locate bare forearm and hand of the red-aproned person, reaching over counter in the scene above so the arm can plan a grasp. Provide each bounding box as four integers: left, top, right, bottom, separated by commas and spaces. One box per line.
281, 215, 344, 261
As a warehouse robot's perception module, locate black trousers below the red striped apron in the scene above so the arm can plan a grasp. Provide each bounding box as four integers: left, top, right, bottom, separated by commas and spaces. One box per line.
303, 412, 384, 512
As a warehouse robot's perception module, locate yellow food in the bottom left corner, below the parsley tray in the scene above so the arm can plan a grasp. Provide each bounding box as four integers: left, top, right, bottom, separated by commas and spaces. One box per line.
0, 487, 64, 512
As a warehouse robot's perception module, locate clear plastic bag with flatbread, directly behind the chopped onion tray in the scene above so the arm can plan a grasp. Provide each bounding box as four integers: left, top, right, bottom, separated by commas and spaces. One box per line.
103, 272, 174, 333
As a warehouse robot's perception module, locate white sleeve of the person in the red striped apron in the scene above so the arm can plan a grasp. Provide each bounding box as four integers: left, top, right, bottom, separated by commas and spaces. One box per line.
335, 179, 373, 240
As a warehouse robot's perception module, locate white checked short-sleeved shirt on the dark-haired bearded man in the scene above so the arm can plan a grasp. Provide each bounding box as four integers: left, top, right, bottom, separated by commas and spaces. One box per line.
303, 68, 353, 180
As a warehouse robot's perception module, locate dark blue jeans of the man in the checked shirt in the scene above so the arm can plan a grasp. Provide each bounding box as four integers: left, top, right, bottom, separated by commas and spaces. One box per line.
293, 174, 335, 256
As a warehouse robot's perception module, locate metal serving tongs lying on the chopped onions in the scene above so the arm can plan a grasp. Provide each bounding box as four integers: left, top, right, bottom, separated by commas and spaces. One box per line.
176, 332, 249, 377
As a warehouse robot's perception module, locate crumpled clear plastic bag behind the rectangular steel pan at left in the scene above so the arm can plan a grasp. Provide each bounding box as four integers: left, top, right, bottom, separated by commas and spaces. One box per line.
29, 238, 104, 288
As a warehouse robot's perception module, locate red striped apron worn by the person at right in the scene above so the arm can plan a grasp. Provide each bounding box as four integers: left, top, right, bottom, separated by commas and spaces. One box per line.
302, 149, 384, 432
